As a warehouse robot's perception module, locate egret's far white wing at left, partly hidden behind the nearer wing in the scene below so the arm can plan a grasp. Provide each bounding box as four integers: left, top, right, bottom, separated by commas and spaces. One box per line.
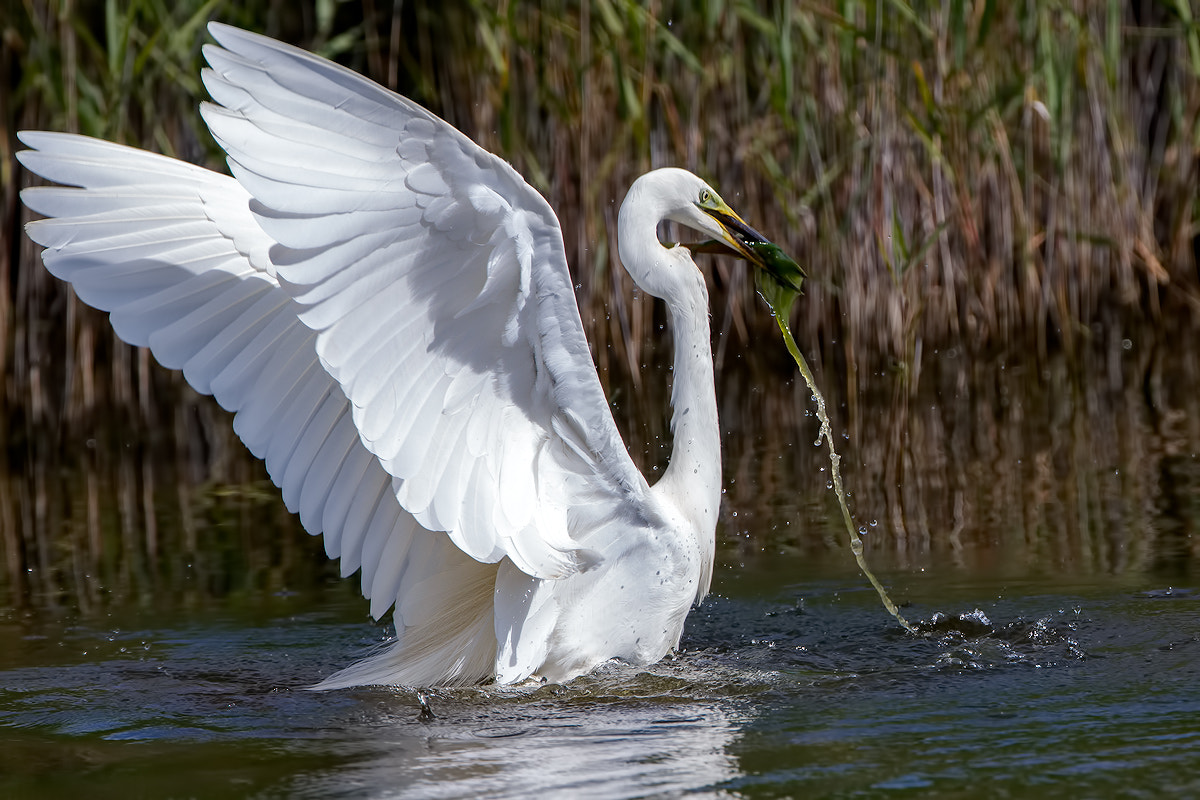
18, 132, 525, 687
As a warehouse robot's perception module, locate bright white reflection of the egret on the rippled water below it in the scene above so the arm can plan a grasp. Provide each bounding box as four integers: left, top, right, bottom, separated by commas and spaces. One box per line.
289, 675, 739, 798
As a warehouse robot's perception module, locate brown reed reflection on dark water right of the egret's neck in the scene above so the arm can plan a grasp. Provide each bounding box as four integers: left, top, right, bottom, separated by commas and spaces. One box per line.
722, 311, 1200, 579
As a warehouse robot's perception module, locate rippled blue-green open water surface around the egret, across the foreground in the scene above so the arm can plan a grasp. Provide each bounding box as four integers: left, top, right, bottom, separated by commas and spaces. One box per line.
0, 546, 1200, 798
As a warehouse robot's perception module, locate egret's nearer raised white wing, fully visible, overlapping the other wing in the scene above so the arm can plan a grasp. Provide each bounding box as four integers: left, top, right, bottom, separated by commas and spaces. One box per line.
203, 25, 646, 578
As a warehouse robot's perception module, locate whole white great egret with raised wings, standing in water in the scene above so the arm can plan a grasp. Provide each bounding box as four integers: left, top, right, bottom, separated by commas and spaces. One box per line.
19, 23, 787, 688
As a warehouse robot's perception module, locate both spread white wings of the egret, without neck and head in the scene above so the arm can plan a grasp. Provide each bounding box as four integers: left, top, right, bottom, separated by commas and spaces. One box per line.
20, 24, 650, 682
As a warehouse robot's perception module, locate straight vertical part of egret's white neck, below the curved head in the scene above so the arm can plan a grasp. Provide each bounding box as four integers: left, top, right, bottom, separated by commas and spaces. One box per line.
659, 271, 721, 535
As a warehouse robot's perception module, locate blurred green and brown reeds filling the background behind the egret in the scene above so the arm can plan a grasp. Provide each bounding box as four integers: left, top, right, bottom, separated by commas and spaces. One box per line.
0, 0, 1200, 609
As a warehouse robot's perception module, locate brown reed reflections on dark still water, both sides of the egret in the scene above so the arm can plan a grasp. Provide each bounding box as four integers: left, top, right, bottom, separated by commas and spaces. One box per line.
9, 316, 1200, 609
